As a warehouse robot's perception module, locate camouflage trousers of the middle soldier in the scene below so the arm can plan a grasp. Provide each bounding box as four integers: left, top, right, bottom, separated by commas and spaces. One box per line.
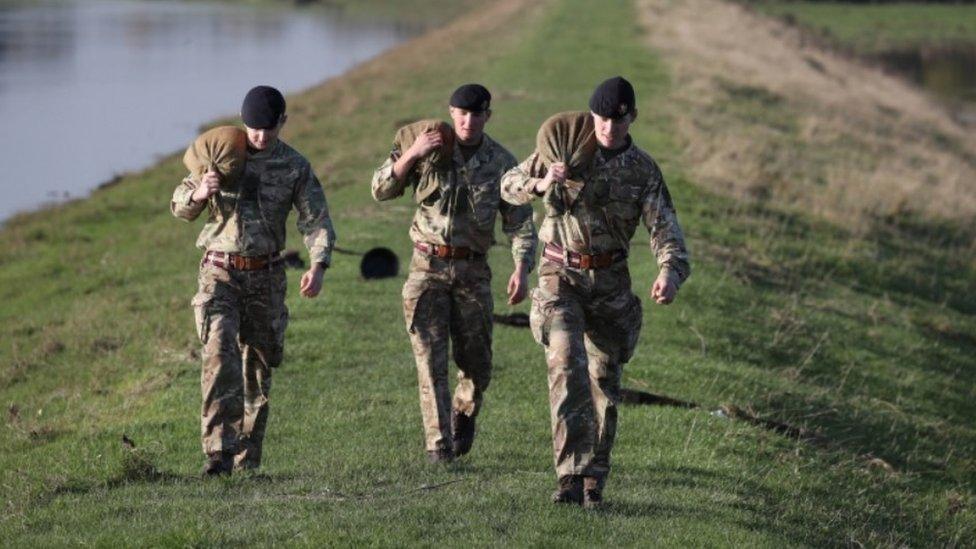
403, 251, 493, 451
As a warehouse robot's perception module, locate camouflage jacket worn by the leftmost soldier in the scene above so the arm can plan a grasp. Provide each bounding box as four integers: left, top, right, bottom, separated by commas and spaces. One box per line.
170, 140, 335, 266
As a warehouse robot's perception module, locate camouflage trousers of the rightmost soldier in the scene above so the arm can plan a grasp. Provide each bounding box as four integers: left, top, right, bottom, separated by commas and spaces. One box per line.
529, 261, 643, 479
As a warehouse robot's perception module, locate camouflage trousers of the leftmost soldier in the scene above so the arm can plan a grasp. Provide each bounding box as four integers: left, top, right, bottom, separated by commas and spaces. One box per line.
192, 264, 288, 468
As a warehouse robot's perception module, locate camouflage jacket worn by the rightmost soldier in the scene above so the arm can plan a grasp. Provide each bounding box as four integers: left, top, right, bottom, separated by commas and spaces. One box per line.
502, 137, 691, 285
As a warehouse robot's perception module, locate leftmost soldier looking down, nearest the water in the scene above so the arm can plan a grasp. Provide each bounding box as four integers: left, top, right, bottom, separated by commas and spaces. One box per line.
170, 86, 335, 475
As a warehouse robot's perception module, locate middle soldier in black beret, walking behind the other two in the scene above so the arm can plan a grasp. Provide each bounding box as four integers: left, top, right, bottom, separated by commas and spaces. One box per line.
372, 84, 536, 463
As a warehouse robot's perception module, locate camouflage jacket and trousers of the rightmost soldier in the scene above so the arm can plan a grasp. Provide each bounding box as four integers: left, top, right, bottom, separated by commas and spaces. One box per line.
502, 137, 690, 482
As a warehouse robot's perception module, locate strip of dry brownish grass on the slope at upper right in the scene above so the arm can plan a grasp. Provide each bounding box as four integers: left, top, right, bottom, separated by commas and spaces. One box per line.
638, 0, 976, 228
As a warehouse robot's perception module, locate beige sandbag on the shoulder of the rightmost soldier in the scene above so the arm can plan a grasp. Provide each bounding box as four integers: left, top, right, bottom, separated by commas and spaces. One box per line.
535, 111, 597, 179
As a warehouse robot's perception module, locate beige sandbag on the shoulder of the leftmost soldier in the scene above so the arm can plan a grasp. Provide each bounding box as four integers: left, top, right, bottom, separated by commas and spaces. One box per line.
183, 126, 247, 190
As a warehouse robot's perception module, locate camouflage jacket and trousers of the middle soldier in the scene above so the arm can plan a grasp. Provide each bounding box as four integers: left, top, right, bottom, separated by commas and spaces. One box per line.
372, 135, 536, 451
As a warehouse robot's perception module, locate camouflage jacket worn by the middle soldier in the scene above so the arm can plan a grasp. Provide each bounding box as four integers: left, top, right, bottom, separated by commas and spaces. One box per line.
372, 135, 537, 268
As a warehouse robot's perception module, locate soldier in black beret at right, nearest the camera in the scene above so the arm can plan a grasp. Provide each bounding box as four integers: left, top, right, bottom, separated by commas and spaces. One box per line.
502, 77, 690, 508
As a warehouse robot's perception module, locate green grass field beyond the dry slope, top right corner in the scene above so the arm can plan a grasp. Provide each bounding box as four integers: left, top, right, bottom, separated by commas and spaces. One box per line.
749, 0, 976, 55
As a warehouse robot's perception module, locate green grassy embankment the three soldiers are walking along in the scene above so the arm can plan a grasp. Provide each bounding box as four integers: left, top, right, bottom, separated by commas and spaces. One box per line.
0, 0, 976, 546
